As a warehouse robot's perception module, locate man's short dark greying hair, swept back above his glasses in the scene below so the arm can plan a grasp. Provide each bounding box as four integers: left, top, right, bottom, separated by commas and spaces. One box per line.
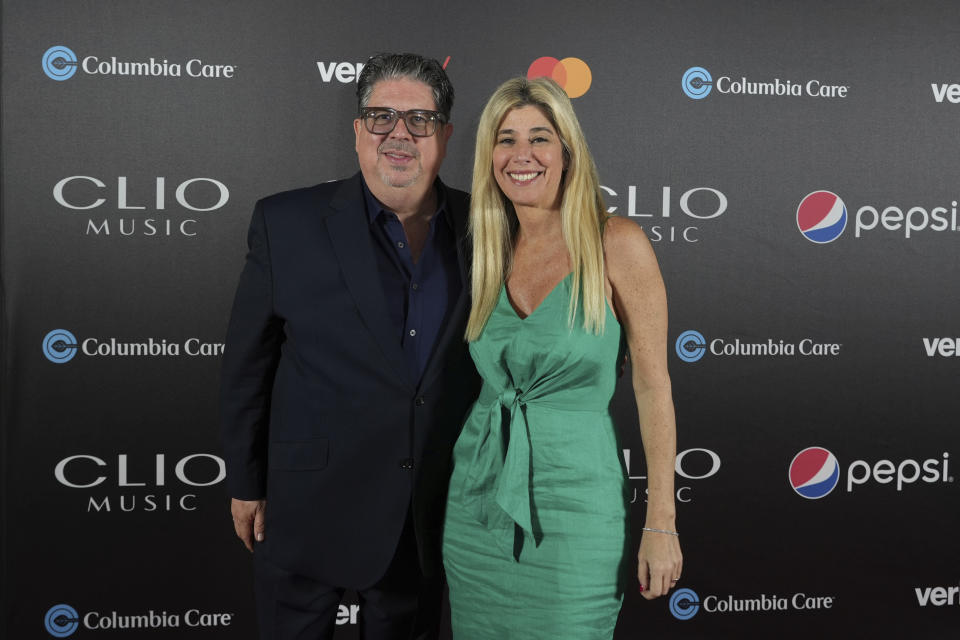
357, 53, 453, 122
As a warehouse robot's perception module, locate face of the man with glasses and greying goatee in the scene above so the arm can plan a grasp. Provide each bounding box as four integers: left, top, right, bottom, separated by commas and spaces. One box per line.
353, 78, 453, 193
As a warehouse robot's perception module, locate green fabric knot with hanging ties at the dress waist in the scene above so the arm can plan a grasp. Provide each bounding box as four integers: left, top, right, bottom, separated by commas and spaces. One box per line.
463, 385, 543, 559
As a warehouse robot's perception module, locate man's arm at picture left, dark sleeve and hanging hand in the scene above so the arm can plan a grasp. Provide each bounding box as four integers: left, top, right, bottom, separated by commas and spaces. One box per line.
220, 202, 283, 550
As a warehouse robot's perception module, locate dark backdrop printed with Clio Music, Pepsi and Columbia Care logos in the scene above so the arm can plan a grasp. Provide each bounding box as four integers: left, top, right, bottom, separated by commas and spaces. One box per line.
0, 0, 960, 640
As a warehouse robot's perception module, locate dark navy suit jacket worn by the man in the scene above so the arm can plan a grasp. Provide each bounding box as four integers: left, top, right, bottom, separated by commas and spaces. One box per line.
221, 173, 478, 588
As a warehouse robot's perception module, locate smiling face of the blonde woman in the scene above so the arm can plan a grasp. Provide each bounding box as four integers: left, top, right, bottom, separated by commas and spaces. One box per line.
493, 105, 566, 209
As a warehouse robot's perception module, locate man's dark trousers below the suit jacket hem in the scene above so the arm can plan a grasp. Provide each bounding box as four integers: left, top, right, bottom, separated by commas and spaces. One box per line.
254, 514, 442, 640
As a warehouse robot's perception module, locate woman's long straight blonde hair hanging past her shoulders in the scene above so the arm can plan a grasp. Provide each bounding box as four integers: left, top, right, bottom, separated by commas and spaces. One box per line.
466, 77, 607, 341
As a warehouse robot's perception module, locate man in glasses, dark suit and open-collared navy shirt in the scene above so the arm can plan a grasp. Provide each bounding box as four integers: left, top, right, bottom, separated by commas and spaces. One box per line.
221, 54, 477, 640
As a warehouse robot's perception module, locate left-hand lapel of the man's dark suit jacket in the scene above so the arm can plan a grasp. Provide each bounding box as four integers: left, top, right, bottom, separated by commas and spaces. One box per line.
326, 173, 414, 390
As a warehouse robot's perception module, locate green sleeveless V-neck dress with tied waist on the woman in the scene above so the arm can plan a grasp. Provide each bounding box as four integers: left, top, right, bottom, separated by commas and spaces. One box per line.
443, 275, 628, 640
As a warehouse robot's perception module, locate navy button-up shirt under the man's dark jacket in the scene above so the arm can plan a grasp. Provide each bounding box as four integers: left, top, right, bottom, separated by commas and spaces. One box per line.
363, 182, 462, 381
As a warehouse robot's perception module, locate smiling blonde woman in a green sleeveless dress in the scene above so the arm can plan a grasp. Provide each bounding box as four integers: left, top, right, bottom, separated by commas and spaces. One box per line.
443, 78, 682, 640
